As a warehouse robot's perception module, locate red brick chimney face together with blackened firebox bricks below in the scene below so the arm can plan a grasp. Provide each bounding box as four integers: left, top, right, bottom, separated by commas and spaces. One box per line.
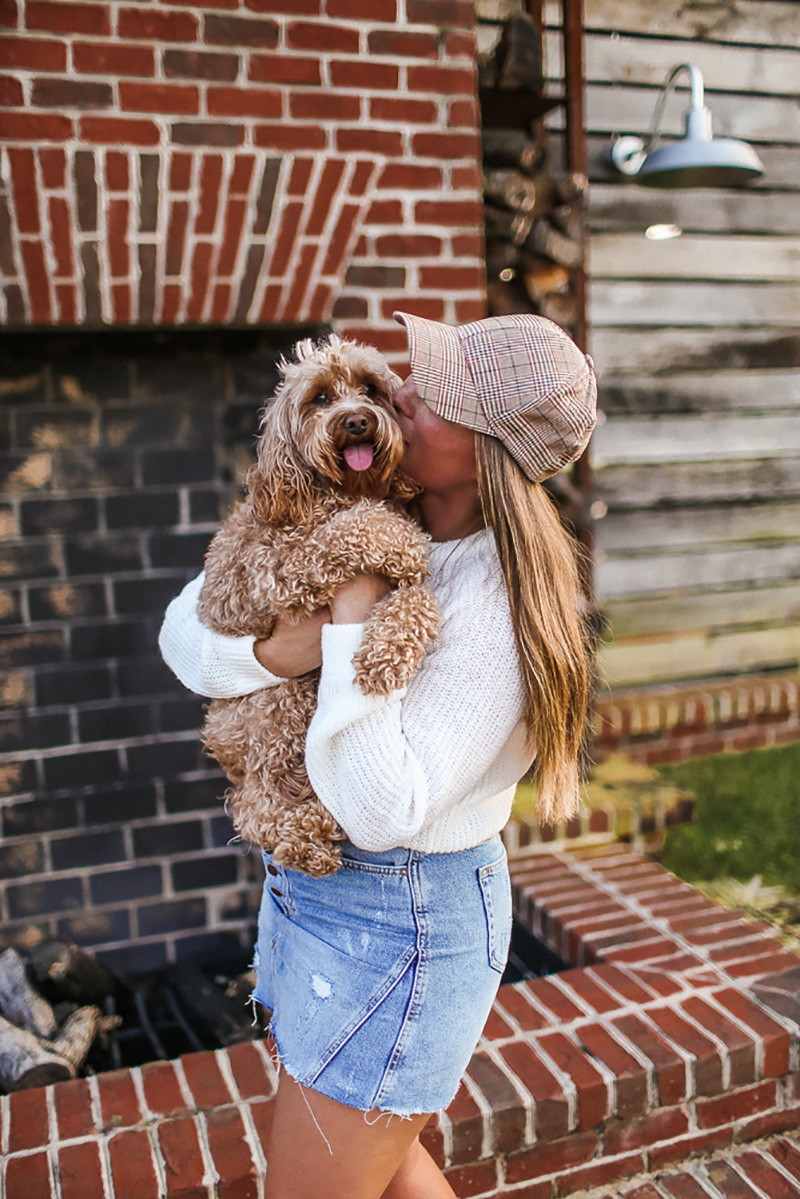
0, 0, 485, 970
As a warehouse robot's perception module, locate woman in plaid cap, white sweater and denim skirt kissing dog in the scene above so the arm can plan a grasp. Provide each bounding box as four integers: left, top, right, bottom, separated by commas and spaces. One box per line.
162, 313, 596, 1199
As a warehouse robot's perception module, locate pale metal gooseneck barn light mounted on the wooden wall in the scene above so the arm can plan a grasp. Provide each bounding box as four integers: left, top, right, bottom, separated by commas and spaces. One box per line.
610, 62, 764, 187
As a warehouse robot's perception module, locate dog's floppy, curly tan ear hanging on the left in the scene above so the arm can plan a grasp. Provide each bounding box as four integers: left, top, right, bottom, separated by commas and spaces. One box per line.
247, 406, 315, 525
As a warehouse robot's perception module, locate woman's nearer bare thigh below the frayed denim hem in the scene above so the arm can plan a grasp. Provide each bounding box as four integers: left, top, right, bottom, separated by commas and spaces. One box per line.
265, 1072, 434, 1199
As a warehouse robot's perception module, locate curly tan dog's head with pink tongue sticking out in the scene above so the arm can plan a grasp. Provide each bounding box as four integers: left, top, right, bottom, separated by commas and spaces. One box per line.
251, 335, 414, 520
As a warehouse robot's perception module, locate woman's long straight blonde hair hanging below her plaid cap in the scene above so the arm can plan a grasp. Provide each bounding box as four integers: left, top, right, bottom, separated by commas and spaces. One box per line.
475, 434, 590, 821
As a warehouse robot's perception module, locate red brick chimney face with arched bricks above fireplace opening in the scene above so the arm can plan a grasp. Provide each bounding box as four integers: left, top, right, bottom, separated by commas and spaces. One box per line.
0, 0, 485, 355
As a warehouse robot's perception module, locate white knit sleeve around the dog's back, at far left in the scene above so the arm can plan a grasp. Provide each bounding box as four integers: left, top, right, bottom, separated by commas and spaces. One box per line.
158, 574, 282, 699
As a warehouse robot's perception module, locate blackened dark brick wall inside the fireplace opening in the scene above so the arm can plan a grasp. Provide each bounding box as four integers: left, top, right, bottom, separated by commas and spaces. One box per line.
0, 326, 328, 970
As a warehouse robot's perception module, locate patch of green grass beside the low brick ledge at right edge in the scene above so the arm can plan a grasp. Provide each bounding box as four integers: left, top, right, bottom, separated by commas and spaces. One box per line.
658, 742, 800, 893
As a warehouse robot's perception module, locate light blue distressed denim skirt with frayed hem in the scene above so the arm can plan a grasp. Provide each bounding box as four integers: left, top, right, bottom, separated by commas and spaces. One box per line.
253, 836, 511, 1116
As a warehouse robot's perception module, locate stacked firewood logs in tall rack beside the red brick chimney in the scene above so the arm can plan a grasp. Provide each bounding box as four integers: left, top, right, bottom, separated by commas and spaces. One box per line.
479, 13, 587, 333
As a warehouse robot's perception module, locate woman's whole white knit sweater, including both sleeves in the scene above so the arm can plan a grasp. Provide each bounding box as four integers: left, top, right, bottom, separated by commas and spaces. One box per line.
158, 530, 531, 854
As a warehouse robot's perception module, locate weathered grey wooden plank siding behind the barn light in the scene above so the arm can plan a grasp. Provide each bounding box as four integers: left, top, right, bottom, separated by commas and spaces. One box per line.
546, 0, 800, 688
